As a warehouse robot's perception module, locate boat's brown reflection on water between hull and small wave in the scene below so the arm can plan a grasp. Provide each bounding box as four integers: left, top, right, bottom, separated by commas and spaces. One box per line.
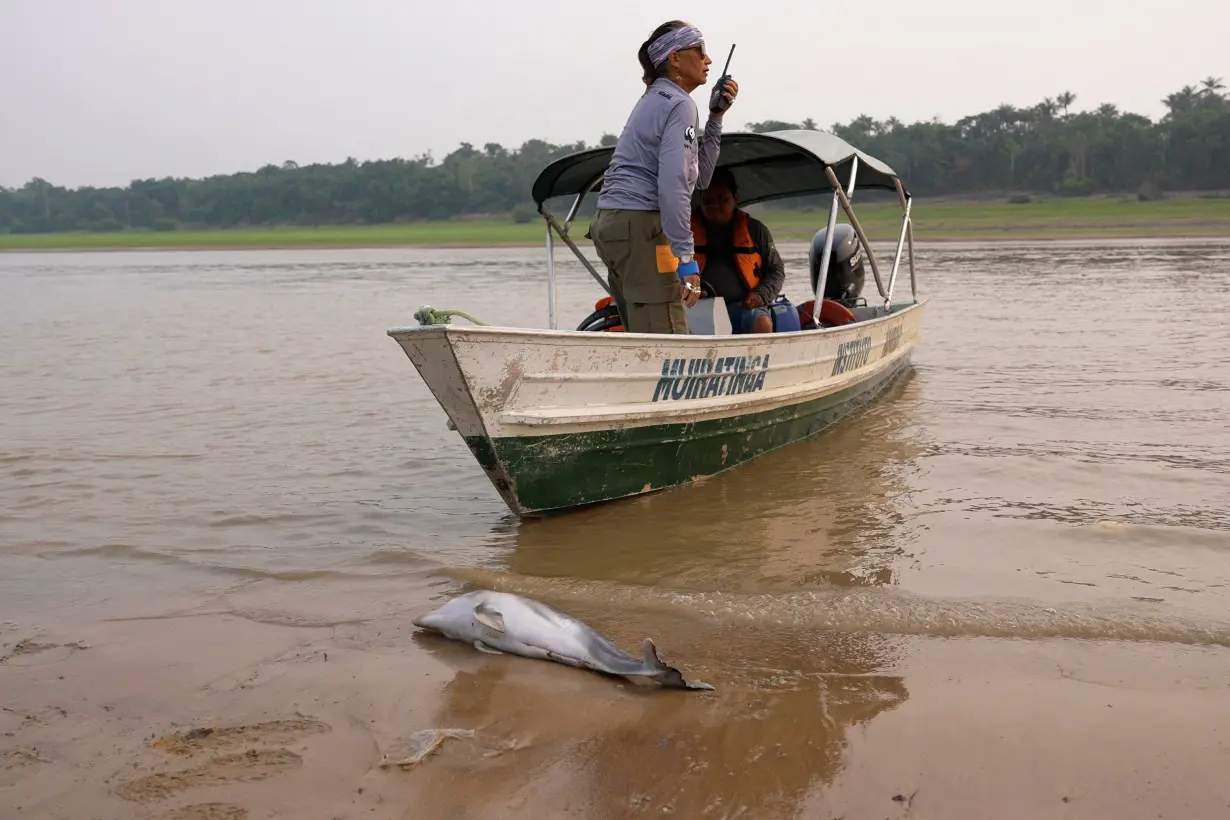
493, 370, 926, 593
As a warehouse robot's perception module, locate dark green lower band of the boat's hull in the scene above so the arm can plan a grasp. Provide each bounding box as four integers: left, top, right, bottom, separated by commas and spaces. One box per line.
466, 355, 909, 515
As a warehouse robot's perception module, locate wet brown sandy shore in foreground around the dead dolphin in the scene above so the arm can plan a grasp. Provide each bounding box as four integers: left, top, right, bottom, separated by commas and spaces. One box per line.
7, 581, 1230, 820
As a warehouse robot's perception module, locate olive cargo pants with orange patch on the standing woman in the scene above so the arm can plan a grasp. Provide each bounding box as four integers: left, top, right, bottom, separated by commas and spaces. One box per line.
587, 209, 688, 333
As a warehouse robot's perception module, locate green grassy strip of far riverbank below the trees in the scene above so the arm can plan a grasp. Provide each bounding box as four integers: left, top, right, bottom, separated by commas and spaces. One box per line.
0, 194, 1230, 251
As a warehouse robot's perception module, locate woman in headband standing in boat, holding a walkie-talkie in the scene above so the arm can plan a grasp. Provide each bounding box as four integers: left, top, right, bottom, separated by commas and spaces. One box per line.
587, 20, 739, 333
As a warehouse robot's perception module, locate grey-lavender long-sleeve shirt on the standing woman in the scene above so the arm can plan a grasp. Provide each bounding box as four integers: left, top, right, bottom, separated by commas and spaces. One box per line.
598, 77, 722, 257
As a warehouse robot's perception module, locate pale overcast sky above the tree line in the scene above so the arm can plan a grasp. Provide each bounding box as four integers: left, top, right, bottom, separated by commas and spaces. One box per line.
0, 0, 1230, 187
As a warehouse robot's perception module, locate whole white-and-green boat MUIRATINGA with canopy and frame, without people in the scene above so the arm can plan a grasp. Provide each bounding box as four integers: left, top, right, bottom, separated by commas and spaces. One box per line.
387, 129, 926, 518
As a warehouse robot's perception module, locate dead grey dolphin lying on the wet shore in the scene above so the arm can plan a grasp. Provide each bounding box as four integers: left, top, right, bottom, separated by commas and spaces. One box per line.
413, 589, 713, 690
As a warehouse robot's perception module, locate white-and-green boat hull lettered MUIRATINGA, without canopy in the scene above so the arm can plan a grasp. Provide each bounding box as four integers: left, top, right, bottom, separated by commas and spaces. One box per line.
389, 302, 925, 515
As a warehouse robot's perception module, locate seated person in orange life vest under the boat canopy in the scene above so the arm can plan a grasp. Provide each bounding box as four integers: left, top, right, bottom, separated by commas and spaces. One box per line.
692, 168, 786, 333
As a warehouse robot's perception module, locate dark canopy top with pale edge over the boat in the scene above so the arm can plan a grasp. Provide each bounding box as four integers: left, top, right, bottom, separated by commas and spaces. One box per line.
533, 129, 909, 210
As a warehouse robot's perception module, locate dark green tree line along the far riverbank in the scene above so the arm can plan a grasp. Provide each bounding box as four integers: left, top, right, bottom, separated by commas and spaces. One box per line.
0, 77, 1230, 234
